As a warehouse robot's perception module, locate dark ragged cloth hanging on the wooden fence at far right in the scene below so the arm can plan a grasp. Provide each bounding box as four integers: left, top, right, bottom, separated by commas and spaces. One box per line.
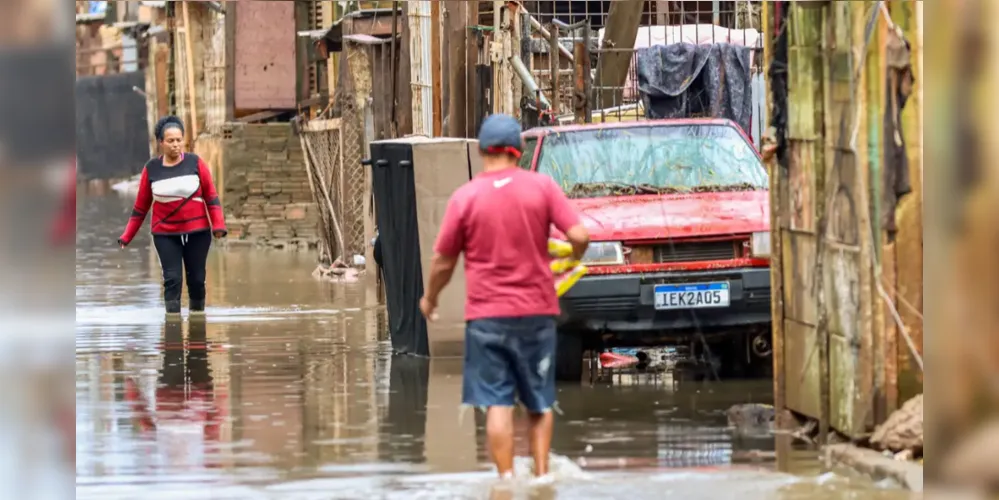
881, 30, 915, 241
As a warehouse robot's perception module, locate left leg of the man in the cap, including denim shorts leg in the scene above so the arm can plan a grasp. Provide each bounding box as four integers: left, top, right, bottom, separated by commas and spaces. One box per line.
462, 319, 516, 477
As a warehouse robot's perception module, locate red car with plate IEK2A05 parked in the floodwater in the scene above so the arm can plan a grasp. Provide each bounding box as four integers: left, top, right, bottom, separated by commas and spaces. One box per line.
521, 119, 771, 380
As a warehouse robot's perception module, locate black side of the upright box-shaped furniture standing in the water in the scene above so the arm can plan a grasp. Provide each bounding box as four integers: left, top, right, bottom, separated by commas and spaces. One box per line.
370, 142, 430, 356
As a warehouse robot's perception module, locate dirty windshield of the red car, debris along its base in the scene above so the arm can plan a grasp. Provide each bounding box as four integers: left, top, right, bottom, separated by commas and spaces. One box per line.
538, 125, 768, 198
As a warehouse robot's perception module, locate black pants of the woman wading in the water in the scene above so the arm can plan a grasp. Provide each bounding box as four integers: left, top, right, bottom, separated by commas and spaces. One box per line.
153, 231, 212, 304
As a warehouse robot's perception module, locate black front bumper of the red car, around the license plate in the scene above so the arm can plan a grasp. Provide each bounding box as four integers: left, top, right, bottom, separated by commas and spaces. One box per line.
560, 268, 771, 333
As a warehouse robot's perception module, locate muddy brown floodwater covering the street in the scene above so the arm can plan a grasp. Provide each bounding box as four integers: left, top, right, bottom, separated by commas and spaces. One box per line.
76, 195, 909, 500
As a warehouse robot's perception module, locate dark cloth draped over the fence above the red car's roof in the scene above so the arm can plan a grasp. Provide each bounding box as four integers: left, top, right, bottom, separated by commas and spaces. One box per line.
635, 43, 753, 134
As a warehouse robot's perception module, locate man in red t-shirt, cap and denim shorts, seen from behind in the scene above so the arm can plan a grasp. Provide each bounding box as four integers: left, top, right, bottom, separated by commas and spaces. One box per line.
420, 115, 589, 478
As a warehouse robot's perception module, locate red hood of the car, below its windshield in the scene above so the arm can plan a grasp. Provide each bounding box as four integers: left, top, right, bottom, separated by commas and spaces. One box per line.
570, 191, 770, 241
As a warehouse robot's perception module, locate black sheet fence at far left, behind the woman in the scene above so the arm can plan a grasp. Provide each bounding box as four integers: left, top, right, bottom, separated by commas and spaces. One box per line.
76, 72, 149, 179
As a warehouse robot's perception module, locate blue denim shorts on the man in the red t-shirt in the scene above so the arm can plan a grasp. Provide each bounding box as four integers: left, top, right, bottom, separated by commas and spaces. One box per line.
462, 316, 557, 414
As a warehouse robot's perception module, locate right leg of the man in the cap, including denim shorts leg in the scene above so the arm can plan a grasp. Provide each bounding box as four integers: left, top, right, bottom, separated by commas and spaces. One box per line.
514, 317, 556, 476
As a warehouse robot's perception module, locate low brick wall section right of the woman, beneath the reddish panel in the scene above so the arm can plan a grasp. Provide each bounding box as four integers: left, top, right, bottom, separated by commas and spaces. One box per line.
219, 123, 319, 249
